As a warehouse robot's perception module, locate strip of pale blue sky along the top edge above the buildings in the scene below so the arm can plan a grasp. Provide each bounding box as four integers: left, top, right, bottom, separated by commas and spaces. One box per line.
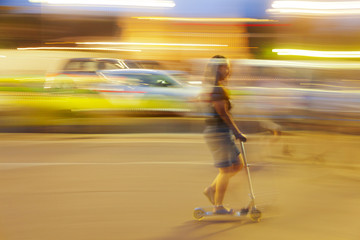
0, 0, 271, 18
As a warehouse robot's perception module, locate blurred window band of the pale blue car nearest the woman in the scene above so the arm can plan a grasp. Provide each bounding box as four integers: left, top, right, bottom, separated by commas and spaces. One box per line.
103, 72, 182, 87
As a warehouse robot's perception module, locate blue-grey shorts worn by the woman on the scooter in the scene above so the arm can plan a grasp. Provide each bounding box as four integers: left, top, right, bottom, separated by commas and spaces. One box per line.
204, 126, 240, 168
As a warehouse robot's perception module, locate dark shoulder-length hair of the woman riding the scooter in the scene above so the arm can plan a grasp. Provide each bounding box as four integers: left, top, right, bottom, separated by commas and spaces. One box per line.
204, 55, 229, 86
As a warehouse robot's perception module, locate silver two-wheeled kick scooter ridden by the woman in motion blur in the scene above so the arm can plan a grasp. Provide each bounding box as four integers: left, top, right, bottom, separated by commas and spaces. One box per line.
193, 141, 261, 222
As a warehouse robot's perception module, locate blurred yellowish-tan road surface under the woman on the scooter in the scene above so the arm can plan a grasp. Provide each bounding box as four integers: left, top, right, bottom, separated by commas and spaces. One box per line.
0, 133, 360, 240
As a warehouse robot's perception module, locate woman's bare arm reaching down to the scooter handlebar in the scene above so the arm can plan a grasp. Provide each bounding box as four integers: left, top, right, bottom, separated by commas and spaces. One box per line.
213, 100, 246, 142
